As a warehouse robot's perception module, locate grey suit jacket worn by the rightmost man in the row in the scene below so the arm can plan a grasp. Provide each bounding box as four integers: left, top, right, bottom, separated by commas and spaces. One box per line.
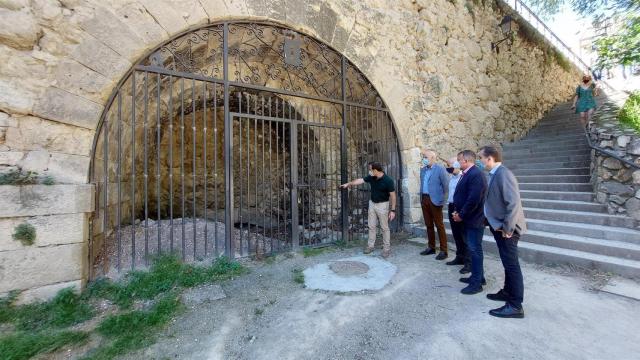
485, 165, 527, 235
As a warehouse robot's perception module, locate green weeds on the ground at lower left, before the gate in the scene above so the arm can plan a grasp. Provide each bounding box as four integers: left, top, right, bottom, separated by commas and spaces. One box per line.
0, 256, 247, 359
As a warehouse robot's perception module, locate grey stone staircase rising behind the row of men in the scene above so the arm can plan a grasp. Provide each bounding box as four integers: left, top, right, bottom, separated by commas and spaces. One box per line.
413, 103, 640, 278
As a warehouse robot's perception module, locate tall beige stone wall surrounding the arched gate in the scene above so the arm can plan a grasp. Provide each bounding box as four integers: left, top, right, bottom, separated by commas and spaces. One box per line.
0, 0, 578, 300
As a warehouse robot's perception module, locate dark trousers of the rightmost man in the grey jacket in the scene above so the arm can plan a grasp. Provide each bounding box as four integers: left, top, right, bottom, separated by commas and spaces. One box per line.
490, 228, 524, 309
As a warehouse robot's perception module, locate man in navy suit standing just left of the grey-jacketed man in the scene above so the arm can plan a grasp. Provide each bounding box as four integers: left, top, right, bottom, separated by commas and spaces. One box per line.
453, 150, 487, 295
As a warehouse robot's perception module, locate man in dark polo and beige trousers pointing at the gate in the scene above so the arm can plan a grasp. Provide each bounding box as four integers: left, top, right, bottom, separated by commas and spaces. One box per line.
341, 162, 396, 258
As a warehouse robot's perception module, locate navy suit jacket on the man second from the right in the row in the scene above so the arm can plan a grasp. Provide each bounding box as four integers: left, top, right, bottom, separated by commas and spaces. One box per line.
453, 165, 487, 229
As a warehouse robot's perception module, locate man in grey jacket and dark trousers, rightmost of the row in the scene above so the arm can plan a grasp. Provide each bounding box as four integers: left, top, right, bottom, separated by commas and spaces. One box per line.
479, 146, 527, 318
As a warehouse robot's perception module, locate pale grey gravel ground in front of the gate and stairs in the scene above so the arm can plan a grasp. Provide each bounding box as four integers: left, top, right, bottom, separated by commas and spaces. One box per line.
116, 238, 640, 360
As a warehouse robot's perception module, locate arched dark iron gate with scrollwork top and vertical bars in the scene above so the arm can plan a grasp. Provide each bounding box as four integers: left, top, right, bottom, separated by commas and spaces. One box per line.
89, 22, 402, 278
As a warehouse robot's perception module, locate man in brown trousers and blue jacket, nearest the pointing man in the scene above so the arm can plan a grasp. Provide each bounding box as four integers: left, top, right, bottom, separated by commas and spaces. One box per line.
420, 149, 449, 260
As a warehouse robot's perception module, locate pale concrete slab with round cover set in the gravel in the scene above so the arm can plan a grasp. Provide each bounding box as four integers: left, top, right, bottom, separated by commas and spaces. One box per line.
304, 256, 397, 292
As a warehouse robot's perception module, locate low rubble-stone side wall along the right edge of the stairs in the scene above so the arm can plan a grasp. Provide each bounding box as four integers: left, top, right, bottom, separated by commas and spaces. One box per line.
589, 97, 640, 221
